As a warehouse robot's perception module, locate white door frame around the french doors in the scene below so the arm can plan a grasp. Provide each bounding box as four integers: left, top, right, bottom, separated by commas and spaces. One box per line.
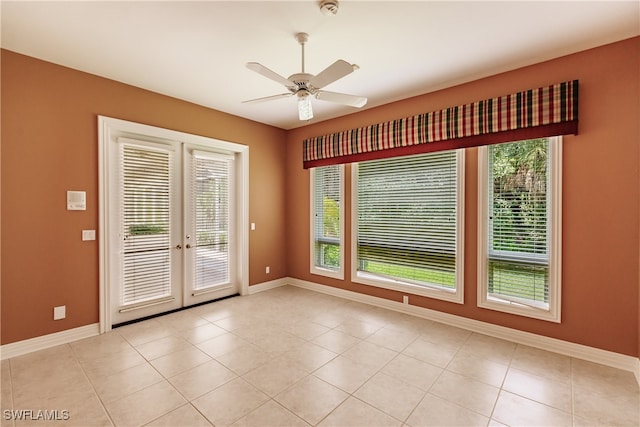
98, 116, 249, 333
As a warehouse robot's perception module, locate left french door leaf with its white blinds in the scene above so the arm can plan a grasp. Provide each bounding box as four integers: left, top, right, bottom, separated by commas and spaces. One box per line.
117, 138, 180, 320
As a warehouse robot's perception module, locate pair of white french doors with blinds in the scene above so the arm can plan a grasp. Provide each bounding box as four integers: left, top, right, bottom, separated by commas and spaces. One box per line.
107, 137, 239, 324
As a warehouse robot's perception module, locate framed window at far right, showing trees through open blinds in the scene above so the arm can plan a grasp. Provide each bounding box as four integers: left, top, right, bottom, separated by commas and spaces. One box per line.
478, 138, 562, 322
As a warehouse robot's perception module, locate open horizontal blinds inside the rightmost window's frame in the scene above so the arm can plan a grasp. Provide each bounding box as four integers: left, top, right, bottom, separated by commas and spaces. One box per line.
488, 139, 550, 306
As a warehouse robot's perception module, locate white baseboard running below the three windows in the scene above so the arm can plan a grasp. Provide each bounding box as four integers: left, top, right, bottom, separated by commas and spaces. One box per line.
288, 278, 640, 384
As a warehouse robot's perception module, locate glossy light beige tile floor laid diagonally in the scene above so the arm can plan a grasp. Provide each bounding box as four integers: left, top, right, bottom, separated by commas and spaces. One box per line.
1, 286, 640, 427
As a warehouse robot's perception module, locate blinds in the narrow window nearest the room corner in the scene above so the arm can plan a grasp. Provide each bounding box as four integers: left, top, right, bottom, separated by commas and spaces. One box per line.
314, 165, 341, 270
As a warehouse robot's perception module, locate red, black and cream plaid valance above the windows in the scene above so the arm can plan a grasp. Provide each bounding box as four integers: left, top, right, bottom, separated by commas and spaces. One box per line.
303, 80, 578, 169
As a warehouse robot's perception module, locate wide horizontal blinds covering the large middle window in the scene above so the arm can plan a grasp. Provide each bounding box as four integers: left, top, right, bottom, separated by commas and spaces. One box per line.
357, 151, 458, 288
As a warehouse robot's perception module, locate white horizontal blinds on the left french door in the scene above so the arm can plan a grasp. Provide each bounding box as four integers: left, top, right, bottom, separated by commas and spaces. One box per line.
120, 144, 173, 306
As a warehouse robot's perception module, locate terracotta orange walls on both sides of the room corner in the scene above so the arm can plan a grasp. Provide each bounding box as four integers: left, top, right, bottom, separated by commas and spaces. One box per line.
0, 38, 640, 355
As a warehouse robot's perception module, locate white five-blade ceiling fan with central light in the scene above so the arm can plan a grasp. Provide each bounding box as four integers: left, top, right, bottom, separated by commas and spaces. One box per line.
244, 33, 367, 120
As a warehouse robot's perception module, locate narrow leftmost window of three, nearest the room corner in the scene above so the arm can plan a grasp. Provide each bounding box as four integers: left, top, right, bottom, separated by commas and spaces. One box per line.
311, 165, 344, 279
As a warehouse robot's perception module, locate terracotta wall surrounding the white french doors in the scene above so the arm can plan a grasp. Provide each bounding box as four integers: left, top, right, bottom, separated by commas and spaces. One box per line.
0, 50, 287, 344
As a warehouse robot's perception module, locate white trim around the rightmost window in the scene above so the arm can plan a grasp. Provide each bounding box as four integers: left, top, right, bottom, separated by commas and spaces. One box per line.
477, 136, 562, 323
